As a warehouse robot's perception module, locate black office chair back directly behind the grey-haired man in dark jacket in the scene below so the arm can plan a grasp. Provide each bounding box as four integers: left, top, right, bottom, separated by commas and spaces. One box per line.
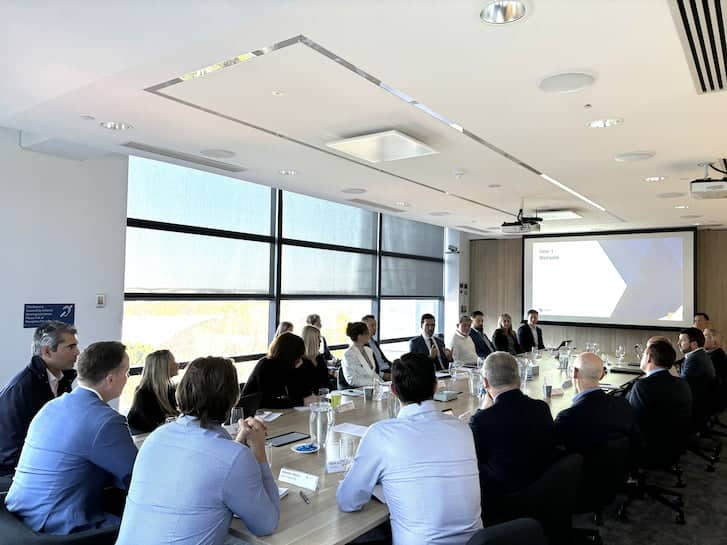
483, 454, 583, 545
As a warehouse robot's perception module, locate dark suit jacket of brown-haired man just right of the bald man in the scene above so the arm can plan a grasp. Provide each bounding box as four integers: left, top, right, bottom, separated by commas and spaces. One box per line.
627, 370, 692, 465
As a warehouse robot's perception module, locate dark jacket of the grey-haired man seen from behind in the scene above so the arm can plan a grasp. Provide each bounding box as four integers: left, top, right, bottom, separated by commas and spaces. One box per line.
470, 390, 555, 504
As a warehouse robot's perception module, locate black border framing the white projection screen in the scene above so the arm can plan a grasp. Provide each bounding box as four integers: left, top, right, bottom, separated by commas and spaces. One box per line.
520, 227, 700, 331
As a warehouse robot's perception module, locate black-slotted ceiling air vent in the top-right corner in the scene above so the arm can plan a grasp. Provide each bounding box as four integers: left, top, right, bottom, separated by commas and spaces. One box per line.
669, 0, 727, 94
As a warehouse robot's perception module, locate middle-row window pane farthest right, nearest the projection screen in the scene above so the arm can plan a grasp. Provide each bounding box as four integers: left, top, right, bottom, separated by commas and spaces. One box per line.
381, 257, 444, 297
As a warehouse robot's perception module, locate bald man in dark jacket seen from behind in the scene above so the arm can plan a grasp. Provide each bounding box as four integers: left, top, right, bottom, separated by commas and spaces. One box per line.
555, 352, 639, 454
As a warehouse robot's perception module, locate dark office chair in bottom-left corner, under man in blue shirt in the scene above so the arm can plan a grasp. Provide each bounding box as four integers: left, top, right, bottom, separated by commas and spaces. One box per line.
0, 497, 119, 545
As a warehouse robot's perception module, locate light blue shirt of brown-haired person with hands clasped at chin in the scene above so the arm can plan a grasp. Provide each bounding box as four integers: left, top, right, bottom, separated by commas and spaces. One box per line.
116, 416, 280, 545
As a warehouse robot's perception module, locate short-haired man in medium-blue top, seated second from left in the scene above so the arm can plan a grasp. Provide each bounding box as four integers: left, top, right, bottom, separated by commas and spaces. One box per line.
5, 342, 136, 535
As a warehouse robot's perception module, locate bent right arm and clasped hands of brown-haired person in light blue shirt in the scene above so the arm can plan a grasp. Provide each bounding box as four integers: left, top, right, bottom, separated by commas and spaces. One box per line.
228, 418, 280, 536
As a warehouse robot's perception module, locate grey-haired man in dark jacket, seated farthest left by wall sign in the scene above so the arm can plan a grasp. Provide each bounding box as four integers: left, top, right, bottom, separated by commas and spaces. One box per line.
0, 321, 79, 477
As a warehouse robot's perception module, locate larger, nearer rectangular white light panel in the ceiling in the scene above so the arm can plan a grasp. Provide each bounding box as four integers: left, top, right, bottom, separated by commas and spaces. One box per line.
326, 131, 437, 163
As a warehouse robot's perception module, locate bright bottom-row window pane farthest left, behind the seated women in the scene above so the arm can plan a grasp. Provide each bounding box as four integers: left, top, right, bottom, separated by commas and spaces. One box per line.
121, 301, 270, 367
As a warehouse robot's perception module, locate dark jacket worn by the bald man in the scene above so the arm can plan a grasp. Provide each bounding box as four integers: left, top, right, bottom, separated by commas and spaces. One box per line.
555, 389, 640, 455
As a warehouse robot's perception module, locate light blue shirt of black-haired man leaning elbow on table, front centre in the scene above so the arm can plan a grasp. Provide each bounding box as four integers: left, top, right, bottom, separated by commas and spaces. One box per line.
337, 401, 482, 545
